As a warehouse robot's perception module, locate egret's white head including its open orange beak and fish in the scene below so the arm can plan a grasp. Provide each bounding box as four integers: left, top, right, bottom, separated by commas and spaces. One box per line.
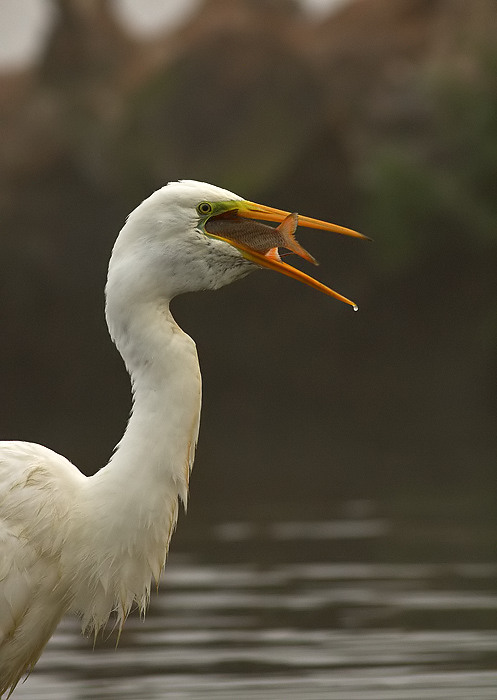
107, 180, 365, 306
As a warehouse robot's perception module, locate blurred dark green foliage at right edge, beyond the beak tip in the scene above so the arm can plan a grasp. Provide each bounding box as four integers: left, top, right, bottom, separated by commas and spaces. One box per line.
364, 52, 497, 273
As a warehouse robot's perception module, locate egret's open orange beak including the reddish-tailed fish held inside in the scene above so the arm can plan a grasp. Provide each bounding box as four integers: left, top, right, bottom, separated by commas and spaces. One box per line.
205, 200, 370, 311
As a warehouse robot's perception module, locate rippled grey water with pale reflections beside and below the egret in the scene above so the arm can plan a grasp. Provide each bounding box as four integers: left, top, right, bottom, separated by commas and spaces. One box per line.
14, 504, 497, 700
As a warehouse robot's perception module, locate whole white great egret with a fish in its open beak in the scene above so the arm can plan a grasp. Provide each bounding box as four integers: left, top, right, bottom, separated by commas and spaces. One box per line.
0, 180, 364, 695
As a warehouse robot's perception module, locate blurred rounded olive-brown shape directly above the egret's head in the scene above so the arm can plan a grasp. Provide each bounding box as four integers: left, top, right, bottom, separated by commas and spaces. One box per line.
115, 33, 321, 200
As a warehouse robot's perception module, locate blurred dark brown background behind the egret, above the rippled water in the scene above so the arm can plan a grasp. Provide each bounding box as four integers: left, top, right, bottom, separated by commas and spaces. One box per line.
0, 0, 497, 521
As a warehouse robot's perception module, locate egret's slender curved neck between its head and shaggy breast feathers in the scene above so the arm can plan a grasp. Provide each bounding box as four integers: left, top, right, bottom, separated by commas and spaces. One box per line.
98, 304, 201, 503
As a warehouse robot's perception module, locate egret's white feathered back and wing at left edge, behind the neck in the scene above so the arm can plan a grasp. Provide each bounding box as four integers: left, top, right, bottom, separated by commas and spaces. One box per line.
0, 441, 85, 696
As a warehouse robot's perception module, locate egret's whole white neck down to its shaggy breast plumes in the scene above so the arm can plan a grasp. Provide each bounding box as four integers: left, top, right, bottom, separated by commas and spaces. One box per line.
74, 302, 201, 628
